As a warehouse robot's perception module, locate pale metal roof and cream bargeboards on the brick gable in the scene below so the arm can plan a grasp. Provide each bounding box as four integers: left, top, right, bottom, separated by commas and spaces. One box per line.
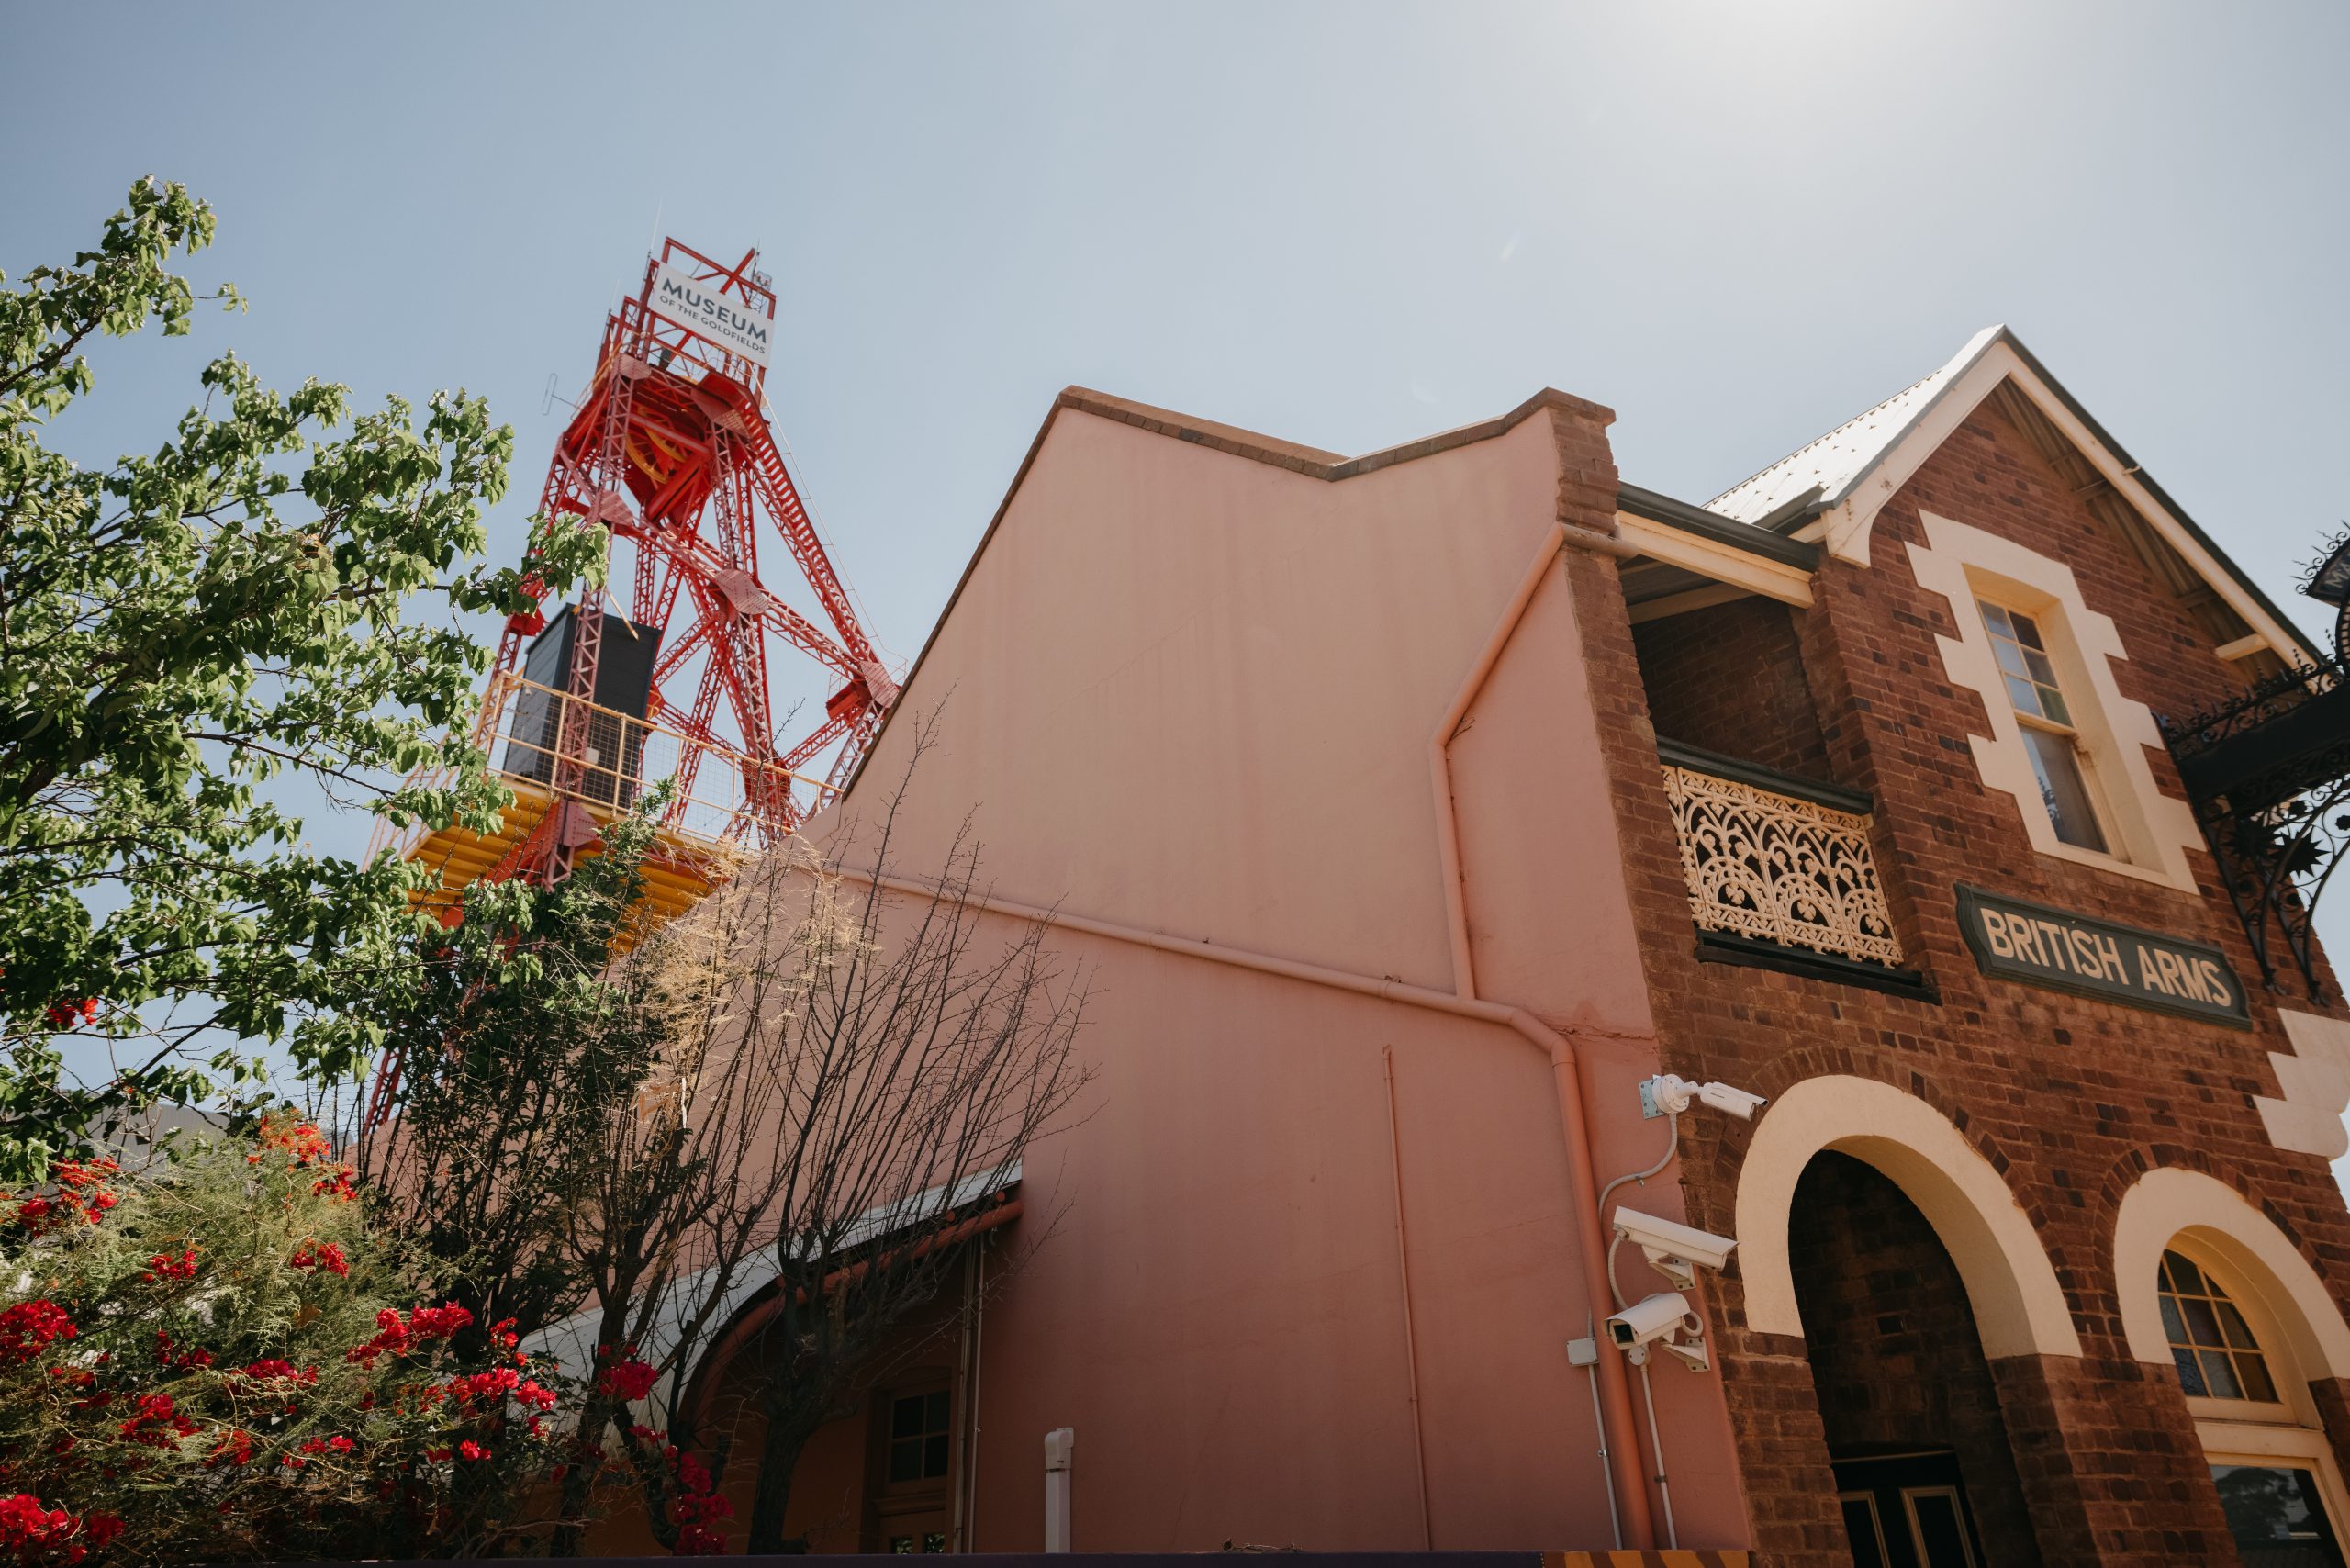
1704, 322, 2317, 663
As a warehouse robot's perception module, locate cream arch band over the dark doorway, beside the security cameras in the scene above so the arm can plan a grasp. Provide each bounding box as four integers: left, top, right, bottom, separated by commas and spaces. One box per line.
1734, 1053, 2082, 1359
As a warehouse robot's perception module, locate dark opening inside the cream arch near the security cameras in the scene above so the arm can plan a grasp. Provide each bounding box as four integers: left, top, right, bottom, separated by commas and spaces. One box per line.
1788, 1154, 2040, 1568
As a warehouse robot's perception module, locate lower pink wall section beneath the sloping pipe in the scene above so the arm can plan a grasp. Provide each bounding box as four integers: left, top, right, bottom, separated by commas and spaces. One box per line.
945, 935, 1607, 1551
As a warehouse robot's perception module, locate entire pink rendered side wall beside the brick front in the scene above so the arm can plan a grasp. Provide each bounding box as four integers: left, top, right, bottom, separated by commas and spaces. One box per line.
818, 399, 1741, 1551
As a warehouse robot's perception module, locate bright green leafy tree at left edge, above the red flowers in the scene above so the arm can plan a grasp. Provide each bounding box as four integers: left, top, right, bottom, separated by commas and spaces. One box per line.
0, 181, 604, 1180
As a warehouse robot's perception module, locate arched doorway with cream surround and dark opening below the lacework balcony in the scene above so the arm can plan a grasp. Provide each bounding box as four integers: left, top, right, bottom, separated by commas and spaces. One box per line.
1734, 1074, 2082, 1568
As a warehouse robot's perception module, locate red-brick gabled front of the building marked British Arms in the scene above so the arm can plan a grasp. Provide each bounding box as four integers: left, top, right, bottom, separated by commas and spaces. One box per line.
1607, 334, 2350, 1563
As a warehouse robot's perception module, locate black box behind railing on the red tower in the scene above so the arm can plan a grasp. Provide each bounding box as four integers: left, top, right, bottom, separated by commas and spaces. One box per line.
500, 604, 660, 809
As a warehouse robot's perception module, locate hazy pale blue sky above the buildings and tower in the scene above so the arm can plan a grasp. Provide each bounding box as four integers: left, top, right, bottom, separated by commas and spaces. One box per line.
0, 0, 2350, 1114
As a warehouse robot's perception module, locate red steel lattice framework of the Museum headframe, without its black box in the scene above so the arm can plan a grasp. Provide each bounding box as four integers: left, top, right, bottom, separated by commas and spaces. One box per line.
491, 240, 898, 881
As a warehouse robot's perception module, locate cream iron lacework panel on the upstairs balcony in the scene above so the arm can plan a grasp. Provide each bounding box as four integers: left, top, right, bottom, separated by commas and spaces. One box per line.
1663, 764, 1901, 966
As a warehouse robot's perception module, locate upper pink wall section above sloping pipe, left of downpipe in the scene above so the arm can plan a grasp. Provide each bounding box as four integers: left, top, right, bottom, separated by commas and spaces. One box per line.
844, 411, 1556, 988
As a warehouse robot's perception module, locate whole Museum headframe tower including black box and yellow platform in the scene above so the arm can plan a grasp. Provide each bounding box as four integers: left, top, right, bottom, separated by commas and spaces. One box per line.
380, 240, 898, 917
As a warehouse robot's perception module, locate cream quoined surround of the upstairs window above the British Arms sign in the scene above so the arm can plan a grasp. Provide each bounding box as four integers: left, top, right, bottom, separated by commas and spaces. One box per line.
1908, 512, 2202, 893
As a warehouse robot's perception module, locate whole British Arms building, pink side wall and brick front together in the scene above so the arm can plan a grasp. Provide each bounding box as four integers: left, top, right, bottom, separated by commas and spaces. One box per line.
592, 331, 2350, 1568
